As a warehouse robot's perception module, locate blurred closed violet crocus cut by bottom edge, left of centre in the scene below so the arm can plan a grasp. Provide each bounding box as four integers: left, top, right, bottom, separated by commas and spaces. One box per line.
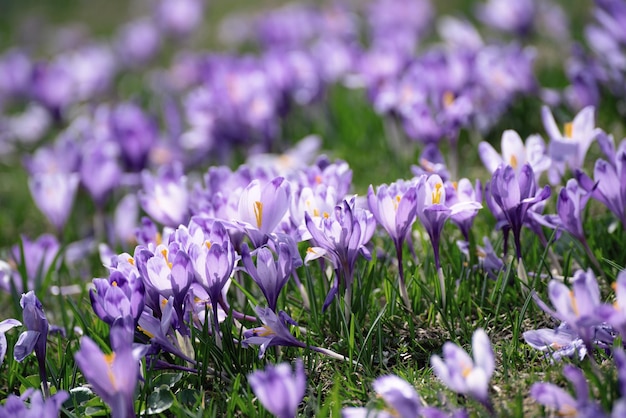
248, 359, 306, 418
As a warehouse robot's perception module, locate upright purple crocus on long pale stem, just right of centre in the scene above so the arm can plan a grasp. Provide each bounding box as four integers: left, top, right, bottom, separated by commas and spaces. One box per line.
367, 182, 417, 308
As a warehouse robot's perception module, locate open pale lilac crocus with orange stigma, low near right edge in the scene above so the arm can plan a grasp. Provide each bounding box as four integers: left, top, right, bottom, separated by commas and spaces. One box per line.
533, 269, 603, 352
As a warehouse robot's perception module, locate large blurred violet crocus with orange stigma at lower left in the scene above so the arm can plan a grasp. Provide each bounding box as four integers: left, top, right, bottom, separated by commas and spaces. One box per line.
74, 325, 143, 418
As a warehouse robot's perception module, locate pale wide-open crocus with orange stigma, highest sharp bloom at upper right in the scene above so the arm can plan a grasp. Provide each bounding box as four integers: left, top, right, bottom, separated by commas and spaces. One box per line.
541, 106, 602, 183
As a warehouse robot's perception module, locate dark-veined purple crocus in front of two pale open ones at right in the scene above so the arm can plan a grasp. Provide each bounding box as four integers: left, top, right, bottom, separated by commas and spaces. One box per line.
487, 164, 551, 261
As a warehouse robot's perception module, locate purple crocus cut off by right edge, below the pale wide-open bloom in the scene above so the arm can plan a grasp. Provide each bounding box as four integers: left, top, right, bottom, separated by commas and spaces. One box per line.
576, 140, 626, 229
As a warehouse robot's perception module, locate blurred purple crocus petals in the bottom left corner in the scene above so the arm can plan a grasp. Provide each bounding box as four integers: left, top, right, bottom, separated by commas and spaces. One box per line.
0, 388, 70, 418
